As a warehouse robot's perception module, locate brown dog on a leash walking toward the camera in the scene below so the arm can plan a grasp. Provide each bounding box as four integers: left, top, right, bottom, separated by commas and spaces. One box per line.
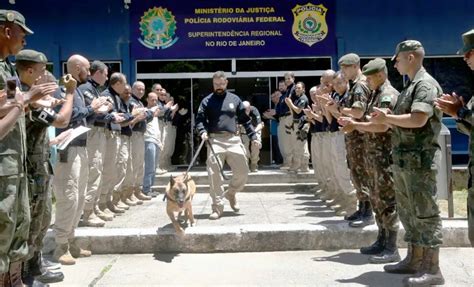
166, 174, 196, 236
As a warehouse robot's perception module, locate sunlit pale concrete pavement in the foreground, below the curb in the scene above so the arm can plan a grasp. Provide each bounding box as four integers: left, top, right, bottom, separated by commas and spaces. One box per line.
56, 248, 474, 286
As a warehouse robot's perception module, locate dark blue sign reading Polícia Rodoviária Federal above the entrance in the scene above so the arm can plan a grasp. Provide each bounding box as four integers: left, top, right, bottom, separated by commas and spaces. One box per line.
130, 0, 336, 59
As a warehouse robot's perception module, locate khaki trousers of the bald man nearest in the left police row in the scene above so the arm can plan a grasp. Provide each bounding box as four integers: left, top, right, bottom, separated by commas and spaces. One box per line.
53, 146, 89, 244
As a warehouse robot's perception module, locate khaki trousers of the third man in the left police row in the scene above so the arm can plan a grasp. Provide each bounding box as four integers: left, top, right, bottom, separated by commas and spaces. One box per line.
100, 129, 120, 200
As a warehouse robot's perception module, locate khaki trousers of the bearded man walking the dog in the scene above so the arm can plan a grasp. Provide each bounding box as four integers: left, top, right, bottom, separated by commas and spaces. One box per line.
206, 134, 249, 206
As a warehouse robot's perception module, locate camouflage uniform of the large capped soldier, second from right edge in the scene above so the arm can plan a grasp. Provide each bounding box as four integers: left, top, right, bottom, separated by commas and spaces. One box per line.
392, 68, 443, 248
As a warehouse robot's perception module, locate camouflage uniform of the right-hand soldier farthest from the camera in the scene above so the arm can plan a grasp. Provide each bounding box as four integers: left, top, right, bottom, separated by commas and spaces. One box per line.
341, 74, 370, 205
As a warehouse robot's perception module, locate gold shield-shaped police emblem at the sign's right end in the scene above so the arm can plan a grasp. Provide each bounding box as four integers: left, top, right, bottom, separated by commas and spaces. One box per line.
291, 3, 328, 47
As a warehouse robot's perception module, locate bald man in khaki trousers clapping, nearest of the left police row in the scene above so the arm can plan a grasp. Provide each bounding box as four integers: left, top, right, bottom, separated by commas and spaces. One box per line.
53, 55, 104, 265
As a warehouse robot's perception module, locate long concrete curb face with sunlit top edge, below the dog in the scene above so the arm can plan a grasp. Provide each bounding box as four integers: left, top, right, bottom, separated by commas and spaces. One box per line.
44, 220, 470, 254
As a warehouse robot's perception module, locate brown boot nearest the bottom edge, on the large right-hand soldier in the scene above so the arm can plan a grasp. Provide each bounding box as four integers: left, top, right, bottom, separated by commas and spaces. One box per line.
403, 247, 444, 286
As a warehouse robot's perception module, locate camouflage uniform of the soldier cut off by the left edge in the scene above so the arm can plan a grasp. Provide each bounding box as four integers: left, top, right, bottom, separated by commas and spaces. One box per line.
0, 59, 30, 273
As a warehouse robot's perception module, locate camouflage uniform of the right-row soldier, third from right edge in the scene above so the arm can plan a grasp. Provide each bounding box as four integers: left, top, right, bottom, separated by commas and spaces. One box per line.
364, 80, 399, 231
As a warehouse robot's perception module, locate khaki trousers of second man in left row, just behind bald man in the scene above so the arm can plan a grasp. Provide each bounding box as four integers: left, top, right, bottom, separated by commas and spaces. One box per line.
84, 126, 108, 210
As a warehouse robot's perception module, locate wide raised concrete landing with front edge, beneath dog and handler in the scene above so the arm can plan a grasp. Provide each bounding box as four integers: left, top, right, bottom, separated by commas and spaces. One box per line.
44, 190, 470, 254
